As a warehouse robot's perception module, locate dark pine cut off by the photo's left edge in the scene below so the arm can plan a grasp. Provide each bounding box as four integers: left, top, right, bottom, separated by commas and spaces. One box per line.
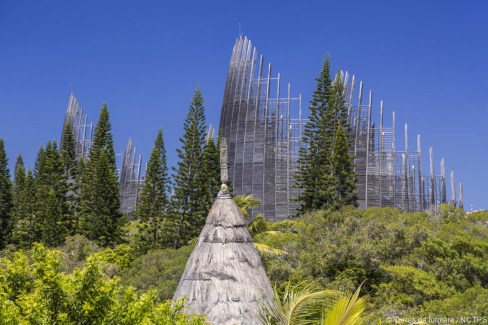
0, 139, 13, 249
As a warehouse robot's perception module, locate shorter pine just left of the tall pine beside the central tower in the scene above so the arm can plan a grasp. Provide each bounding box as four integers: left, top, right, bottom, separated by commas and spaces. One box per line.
136, 129, 172, 252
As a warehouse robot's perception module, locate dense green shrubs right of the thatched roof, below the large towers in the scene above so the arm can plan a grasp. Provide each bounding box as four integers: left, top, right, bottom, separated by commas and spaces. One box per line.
251, 205, 488, 324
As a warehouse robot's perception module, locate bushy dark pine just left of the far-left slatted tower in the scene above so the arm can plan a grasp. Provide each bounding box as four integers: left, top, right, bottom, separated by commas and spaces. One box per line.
35, 141, 70, 247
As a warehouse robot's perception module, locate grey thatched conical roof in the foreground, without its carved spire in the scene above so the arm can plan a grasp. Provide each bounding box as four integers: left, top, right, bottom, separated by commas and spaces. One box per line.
174, 189, 272, 325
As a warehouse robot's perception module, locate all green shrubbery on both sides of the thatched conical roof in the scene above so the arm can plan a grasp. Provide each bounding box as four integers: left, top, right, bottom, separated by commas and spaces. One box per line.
0, 205, 488, 324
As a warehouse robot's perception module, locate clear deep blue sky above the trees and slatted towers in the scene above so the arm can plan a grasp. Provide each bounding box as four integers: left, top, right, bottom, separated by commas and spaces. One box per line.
0, 0, 488, 210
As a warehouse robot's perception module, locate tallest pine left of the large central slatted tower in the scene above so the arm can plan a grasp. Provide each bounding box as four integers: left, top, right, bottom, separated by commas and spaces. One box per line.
171, 88, 206, 247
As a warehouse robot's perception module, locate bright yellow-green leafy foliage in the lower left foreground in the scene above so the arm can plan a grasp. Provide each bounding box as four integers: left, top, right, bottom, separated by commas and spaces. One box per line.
0, 239, 205, 325
